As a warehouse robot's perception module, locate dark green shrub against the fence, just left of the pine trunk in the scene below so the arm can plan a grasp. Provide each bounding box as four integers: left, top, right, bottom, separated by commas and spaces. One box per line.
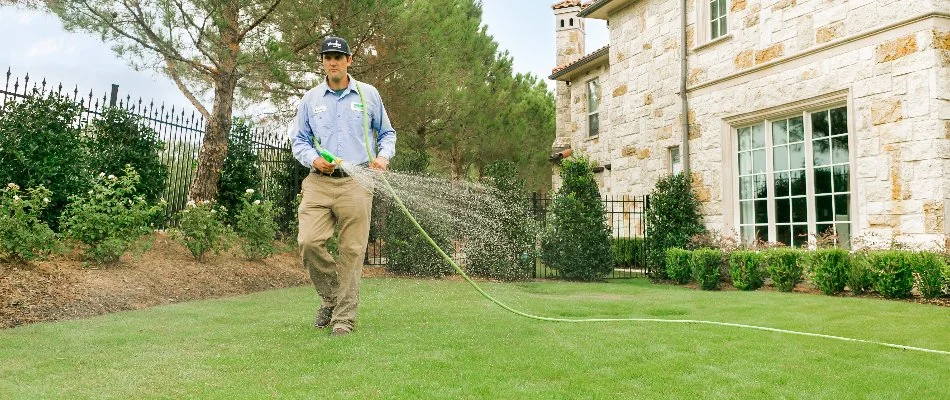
86, 108, 168, 204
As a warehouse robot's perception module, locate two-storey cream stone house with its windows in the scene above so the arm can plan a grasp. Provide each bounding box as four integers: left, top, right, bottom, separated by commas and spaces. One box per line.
550, 0, 950, 245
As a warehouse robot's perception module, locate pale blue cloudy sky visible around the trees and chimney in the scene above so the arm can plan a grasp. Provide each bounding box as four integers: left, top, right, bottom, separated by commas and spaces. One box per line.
0, 0, 608, 114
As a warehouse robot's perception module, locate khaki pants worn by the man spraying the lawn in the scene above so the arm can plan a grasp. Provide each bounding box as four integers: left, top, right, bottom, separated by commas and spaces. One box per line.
297, 173, 373, 330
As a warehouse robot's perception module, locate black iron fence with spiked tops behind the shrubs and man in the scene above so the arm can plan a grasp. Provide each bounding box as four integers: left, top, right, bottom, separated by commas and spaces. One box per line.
0, 68, 649, 278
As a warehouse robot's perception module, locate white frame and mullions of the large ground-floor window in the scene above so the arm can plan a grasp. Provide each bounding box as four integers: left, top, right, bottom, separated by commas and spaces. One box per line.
723, 90, 862, 247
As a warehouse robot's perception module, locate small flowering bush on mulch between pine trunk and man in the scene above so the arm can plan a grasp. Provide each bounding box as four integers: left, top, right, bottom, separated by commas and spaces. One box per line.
235, 189, 277, 260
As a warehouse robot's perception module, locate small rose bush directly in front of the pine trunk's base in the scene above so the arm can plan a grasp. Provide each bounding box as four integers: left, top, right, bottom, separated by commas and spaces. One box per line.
173, 200, 231, 262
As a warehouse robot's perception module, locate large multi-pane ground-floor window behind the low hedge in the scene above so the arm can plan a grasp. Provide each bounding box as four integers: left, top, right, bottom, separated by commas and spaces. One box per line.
736, 107, 851, 247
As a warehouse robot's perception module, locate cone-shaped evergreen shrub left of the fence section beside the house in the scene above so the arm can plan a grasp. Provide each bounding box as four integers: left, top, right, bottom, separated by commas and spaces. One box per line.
541, 157, 614, 281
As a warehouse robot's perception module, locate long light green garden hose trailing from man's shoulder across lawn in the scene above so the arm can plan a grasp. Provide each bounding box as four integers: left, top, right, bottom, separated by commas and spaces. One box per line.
346, 84, 950, 356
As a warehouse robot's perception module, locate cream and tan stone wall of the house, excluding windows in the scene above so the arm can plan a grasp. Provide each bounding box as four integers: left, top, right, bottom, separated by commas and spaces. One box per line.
558, 0, 950, 241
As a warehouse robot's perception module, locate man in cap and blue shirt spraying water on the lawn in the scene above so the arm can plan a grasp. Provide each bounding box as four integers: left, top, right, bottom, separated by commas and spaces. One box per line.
290, 37, 396, 336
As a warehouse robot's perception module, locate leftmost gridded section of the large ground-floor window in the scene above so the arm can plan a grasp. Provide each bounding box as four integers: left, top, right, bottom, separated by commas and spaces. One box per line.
738, 124, 769, 243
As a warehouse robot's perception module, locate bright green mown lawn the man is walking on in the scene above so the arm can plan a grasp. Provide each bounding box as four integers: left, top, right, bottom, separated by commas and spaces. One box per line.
0, 278, 950, 399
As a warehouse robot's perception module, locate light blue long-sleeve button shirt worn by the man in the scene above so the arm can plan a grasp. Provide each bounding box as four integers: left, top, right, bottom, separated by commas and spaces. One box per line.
288, 76, 396, 169
